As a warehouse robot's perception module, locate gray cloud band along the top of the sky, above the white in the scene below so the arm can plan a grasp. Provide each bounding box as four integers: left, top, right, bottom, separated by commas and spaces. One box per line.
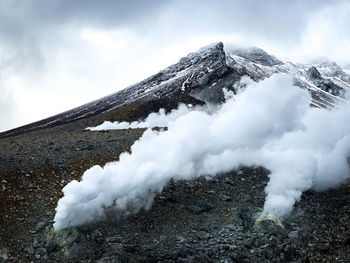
0, 0, 342, 69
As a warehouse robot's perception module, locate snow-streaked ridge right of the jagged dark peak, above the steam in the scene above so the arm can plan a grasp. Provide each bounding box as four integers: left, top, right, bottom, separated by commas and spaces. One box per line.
227, 48, 350, 108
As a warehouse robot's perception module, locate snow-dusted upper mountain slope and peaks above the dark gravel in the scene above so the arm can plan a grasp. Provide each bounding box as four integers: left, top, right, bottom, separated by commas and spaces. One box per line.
0, 42, 350, 136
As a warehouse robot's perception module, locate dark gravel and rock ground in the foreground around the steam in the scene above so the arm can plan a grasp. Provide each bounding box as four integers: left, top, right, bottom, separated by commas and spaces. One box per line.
0, 112, 350, 262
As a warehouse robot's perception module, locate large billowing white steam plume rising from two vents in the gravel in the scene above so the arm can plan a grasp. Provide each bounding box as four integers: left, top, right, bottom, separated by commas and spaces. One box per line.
54, 75, 350, 229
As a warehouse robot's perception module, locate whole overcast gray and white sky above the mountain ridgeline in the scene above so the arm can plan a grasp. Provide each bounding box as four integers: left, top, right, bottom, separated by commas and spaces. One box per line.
0, 0, 350, 131
